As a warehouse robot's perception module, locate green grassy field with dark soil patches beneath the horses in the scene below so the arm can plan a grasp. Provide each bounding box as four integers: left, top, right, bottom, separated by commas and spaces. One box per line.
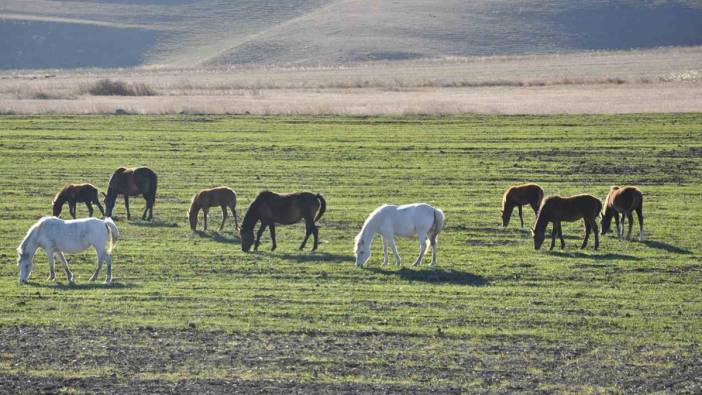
0, 114, 702, 392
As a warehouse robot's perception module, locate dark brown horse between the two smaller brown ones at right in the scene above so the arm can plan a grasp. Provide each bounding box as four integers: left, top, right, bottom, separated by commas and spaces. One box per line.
531, 194, 602, 250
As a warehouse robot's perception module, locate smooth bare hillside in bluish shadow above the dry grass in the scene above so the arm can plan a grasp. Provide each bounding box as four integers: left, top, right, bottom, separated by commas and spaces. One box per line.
0, 0, 702, 69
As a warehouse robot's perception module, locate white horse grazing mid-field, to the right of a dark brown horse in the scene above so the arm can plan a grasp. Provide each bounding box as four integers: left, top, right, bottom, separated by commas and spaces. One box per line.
354, 203, 446, 267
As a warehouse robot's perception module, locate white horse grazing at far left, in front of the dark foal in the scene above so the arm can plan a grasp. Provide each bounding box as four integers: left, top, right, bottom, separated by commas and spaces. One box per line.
17, 217, 120, 284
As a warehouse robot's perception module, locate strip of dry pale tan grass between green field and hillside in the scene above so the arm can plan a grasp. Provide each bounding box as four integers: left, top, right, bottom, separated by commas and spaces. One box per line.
0, 47, 702, 115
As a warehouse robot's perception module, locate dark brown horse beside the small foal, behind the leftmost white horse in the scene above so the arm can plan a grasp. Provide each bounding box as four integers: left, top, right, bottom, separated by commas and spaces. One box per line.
103, 167, 158, 221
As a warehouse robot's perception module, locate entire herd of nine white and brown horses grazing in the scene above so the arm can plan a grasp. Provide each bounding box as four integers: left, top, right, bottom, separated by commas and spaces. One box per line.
17, 167, 643, 283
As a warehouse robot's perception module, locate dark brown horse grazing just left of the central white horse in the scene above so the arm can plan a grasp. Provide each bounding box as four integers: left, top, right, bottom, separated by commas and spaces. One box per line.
240, 191, 327, 252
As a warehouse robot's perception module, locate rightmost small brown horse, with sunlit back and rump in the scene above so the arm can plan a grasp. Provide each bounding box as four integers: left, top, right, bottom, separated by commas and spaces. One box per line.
602, 186, 643, 241
